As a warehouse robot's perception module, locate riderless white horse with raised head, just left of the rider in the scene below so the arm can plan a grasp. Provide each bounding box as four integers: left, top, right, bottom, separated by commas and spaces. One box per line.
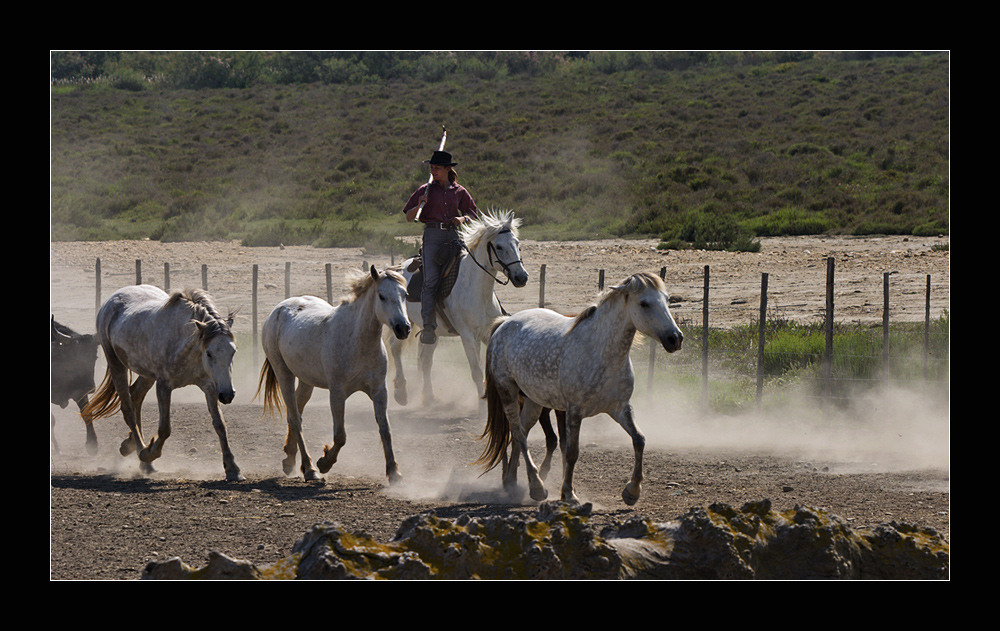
257, 266, 410, 481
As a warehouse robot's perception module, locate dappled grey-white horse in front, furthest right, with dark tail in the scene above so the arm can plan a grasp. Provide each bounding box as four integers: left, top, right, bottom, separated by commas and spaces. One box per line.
480, 273, 684, 505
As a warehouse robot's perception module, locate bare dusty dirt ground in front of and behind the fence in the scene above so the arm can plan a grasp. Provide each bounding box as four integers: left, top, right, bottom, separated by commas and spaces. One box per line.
50, 238, 950, 579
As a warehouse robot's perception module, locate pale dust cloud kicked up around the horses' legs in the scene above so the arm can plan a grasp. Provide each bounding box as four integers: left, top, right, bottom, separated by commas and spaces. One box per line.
52, 316, 950, 494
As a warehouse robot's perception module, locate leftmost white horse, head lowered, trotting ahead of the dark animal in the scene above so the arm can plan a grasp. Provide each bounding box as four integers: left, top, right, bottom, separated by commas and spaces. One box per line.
81, 285, 244, 481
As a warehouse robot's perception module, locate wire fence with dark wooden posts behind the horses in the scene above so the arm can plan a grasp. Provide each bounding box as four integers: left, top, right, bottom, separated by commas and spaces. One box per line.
95, 257, 950, 409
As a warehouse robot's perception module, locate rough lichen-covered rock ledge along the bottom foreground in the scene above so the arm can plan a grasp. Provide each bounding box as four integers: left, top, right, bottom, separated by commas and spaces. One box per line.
143, 500, 949, 580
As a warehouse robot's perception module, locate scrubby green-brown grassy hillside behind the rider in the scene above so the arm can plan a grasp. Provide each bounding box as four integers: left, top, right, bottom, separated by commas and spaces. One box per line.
51, 53, 949, 252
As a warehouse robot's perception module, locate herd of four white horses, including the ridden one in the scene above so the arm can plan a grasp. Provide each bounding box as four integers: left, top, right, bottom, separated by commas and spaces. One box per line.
81, 211, 683, 504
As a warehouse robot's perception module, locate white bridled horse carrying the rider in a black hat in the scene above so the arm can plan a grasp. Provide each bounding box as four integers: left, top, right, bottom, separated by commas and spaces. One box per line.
387, 211, 528, 405
